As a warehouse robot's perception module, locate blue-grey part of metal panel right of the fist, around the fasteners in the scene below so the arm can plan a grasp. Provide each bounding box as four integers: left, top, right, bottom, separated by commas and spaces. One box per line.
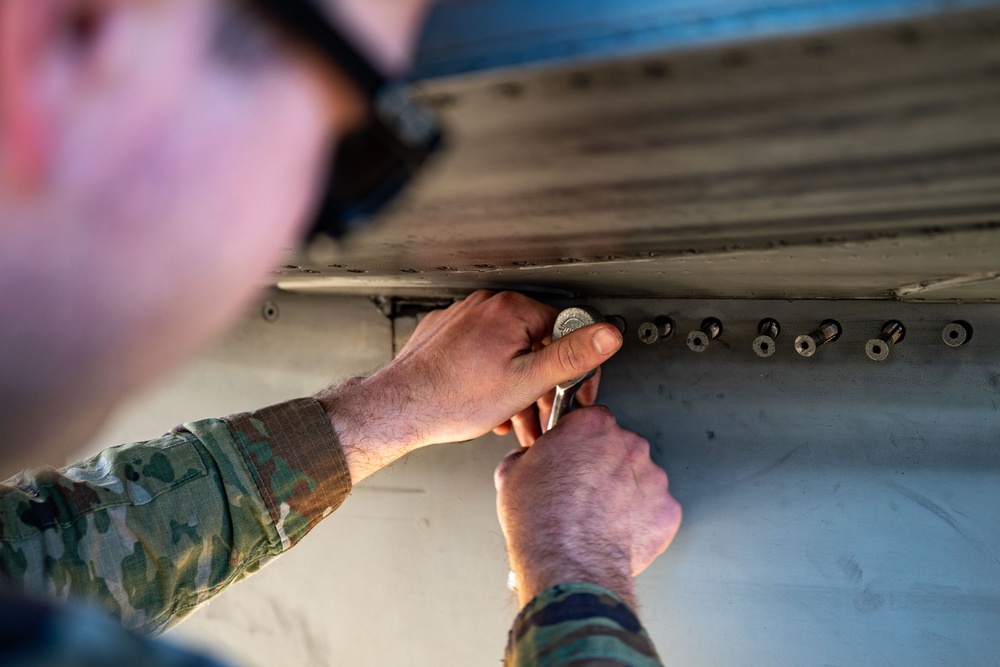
593, 300, 1000, 666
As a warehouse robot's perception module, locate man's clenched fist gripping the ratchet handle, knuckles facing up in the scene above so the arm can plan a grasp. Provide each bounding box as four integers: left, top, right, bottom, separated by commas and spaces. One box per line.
496, 407, 681, 609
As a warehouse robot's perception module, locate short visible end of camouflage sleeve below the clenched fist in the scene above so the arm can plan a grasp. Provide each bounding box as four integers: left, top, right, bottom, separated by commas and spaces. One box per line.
504, 583, 662, 667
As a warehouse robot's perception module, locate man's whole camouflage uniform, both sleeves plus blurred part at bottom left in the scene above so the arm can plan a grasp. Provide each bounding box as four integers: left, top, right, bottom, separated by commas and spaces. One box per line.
0, 399, 659, 667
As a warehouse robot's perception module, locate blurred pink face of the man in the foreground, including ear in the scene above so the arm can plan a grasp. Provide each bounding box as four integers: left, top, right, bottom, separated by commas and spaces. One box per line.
0, 0, 422, 472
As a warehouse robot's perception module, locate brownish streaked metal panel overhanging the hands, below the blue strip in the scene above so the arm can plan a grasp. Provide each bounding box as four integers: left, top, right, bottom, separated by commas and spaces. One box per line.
284, 9, 1000, 301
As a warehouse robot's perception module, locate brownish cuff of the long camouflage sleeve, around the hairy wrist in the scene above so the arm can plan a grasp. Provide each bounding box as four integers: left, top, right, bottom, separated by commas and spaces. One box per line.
223, 398, 351, 549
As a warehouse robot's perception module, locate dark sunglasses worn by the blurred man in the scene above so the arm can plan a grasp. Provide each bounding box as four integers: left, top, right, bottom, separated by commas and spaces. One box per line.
244, 0, 443, 238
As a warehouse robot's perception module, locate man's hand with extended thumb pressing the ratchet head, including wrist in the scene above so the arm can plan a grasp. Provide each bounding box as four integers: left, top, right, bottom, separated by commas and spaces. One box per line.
318, 291, 622, 483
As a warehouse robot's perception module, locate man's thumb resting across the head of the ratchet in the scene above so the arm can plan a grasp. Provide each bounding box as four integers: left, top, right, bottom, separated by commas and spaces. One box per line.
523, 323, 622, 396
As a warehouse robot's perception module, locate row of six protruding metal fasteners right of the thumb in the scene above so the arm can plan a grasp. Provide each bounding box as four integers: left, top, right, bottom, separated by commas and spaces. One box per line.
639, 317, 972, 361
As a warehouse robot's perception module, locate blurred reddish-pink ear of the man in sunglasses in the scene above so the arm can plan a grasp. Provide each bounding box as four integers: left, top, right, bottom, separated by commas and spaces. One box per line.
0, 0, 103, 191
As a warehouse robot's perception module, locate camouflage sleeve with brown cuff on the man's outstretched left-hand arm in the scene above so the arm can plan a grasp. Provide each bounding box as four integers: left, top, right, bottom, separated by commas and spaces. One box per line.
0, 399, 351, 634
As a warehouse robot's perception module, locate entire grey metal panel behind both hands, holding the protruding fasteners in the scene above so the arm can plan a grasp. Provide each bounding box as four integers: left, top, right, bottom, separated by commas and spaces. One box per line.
90, 293, 1000, 667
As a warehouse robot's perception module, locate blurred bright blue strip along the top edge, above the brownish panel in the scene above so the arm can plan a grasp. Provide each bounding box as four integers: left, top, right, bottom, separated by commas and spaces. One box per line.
417, 0, 989, 77
